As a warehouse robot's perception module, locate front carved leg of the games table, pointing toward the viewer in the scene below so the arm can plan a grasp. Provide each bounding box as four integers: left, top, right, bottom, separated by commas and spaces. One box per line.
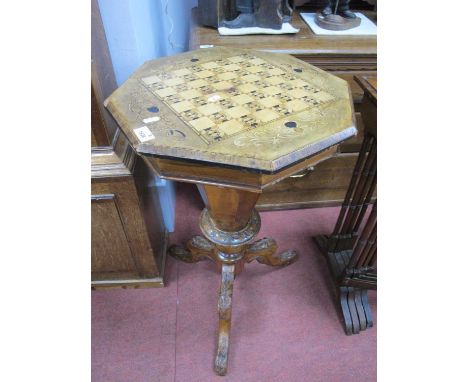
214, 264, 235, 375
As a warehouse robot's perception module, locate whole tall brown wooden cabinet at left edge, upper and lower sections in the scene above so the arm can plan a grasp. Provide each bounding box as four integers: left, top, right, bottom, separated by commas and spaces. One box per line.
91, 0, 167, 289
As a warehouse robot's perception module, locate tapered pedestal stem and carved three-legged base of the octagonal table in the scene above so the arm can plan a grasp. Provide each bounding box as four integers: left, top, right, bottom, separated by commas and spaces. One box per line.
169, 185, 297, 375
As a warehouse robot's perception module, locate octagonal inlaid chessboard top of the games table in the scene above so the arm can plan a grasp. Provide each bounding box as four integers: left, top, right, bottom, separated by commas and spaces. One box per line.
106, 47, 356, 172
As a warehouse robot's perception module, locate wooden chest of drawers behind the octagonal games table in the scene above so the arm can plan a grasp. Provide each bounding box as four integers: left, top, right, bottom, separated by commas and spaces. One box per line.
190, 8, 377, 210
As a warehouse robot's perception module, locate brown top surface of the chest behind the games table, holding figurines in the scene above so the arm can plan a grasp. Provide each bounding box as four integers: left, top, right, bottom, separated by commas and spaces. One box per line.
190, 8, 377, 57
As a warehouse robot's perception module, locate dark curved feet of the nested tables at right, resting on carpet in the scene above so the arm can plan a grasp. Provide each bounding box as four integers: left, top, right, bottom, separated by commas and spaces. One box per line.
314, 235, 374, 335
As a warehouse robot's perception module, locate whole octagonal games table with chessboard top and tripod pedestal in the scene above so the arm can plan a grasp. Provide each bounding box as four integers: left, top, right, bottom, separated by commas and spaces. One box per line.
105, 47, 356, 375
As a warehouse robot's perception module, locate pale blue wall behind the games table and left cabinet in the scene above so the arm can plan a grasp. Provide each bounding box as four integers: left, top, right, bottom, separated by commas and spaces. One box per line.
99, 0, 198, 232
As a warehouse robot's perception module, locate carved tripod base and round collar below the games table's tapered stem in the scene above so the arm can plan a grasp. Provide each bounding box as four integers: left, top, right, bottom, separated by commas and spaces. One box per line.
169, 195, 298, 375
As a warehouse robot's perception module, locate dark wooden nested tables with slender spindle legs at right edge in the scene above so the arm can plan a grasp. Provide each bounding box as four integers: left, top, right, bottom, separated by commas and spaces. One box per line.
314, 77, 377, 335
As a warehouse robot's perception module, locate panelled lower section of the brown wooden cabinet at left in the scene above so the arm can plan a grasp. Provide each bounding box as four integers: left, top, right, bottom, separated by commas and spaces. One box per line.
91, 142, 167, 288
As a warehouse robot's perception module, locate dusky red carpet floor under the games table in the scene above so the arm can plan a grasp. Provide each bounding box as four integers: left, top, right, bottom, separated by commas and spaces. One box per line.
92, 184, 377, 382
